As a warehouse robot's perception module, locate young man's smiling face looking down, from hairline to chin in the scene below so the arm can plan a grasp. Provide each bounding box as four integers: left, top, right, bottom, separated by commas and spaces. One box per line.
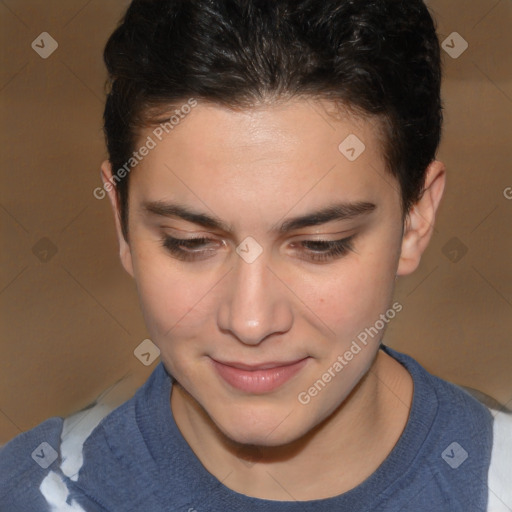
104, 100, 432, 445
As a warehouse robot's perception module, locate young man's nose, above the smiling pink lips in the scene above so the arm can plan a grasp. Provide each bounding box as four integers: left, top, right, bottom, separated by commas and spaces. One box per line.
218, 254, 293, 345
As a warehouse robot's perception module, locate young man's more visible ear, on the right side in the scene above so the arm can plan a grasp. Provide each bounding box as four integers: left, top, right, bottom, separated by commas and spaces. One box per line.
397, 160, 446, 276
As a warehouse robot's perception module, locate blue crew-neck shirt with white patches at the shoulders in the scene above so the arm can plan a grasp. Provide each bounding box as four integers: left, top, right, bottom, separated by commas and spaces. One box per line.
0, 346, 512, 512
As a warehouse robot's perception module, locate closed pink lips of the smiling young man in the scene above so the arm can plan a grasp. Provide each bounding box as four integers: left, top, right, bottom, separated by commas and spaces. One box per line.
212, 357, 309, 394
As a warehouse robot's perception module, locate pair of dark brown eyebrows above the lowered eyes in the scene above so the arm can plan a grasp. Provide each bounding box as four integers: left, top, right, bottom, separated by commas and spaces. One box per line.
142, 201, 377, 234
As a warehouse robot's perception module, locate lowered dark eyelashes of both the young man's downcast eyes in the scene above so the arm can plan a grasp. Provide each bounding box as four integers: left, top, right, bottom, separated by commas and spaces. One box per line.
162, 235, 354, 263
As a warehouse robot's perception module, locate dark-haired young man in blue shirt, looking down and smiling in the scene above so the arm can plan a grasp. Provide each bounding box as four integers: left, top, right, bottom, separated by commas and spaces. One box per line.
0, 0, 512, 512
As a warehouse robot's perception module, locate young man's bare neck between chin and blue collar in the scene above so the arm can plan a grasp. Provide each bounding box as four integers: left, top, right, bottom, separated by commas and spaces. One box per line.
171, 350, 413, 501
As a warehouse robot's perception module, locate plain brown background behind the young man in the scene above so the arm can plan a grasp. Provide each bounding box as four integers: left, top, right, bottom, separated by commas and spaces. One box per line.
0, 0, 512, 443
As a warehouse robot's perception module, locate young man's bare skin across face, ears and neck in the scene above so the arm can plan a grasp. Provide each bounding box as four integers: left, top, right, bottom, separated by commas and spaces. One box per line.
102, 99, 445, 501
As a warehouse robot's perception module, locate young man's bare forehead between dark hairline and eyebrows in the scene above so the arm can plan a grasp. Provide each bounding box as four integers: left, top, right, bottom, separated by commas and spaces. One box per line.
130, 100, 398, 224
